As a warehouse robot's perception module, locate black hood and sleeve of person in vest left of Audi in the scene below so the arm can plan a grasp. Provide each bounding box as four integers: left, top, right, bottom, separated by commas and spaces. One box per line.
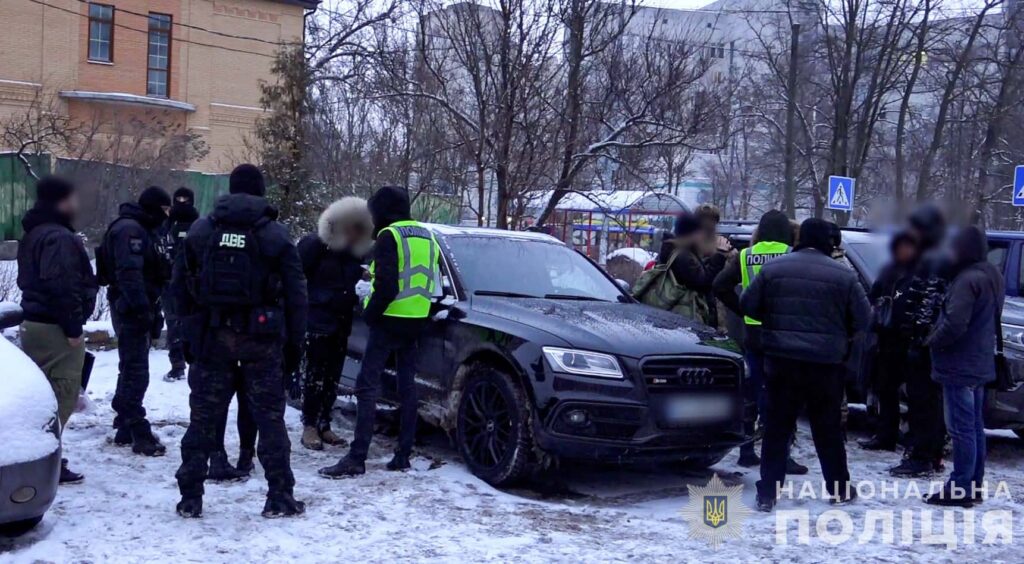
362, 186, 413, 324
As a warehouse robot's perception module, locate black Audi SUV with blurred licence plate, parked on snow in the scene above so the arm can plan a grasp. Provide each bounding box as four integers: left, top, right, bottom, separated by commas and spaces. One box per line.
342, 225, 748, 485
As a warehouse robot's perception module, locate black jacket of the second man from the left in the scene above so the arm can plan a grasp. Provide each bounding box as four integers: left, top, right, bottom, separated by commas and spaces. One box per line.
100, 202, 168, 319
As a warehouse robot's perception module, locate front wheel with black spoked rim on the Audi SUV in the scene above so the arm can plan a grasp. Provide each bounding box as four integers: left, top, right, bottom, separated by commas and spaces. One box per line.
456, 364, 534, 487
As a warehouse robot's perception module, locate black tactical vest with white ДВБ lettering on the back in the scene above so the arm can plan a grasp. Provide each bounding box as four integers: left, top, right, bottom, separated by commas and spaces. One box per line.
196, 218, 269, 308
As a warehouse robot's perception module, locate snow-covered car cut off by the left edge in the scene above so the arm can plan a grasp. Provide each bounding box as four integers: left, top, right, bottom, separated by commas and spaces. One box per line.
0, 303, 60, 535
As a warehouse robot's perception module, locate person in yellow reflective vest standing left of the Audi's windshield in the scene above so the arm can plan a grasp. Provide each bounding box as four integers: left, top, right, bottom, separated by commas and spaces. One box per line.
319, 186, 440, 478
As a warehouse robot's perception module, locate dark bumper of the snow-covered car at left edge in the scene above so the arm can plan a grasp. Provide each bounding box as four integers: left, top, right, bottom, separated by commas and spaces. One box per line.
0, 448, 60, 525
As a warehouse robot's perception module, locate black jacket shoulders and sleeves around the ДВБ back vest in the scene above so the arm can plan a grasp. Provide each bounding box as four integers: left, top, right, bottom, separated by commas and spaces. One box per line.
171, 193, 308, 350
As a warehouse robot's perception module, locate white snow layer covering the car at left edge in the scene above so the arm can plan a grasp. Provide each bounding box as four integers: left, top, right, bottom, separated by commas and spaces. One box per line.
0, 337, 60, 467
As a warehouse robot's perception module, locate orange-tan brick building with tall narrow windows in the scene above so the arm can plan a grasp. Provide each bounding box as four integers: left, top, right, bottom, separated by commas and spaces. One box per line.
0, 0, 318, 173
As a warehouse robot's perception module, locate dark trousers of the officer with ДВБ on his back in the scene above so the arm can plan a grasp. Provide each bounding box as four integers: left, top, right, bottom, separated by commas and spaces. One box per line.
176, 329, 295, 496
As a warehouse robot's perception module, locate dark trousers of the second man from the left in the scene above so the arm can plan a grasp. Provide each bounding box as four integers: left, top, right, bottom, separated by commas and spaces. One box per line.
111, 308, 153, 428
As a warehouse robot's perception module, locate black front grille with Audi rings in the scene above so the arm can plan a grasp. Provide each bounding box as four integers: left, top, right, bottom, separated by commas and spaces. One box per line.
640, 356, 742, 393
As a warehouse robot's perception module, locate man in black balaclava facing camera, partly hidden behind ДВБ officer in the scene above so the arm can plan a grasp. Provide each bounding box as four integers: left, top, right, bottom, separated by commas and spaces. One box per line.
161, 186, 199, 382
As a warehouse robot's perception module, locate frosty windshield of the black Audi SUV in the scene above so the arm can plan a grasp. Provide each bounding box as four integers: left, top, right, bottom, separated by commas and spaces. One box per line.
447, 235, 623, 302
